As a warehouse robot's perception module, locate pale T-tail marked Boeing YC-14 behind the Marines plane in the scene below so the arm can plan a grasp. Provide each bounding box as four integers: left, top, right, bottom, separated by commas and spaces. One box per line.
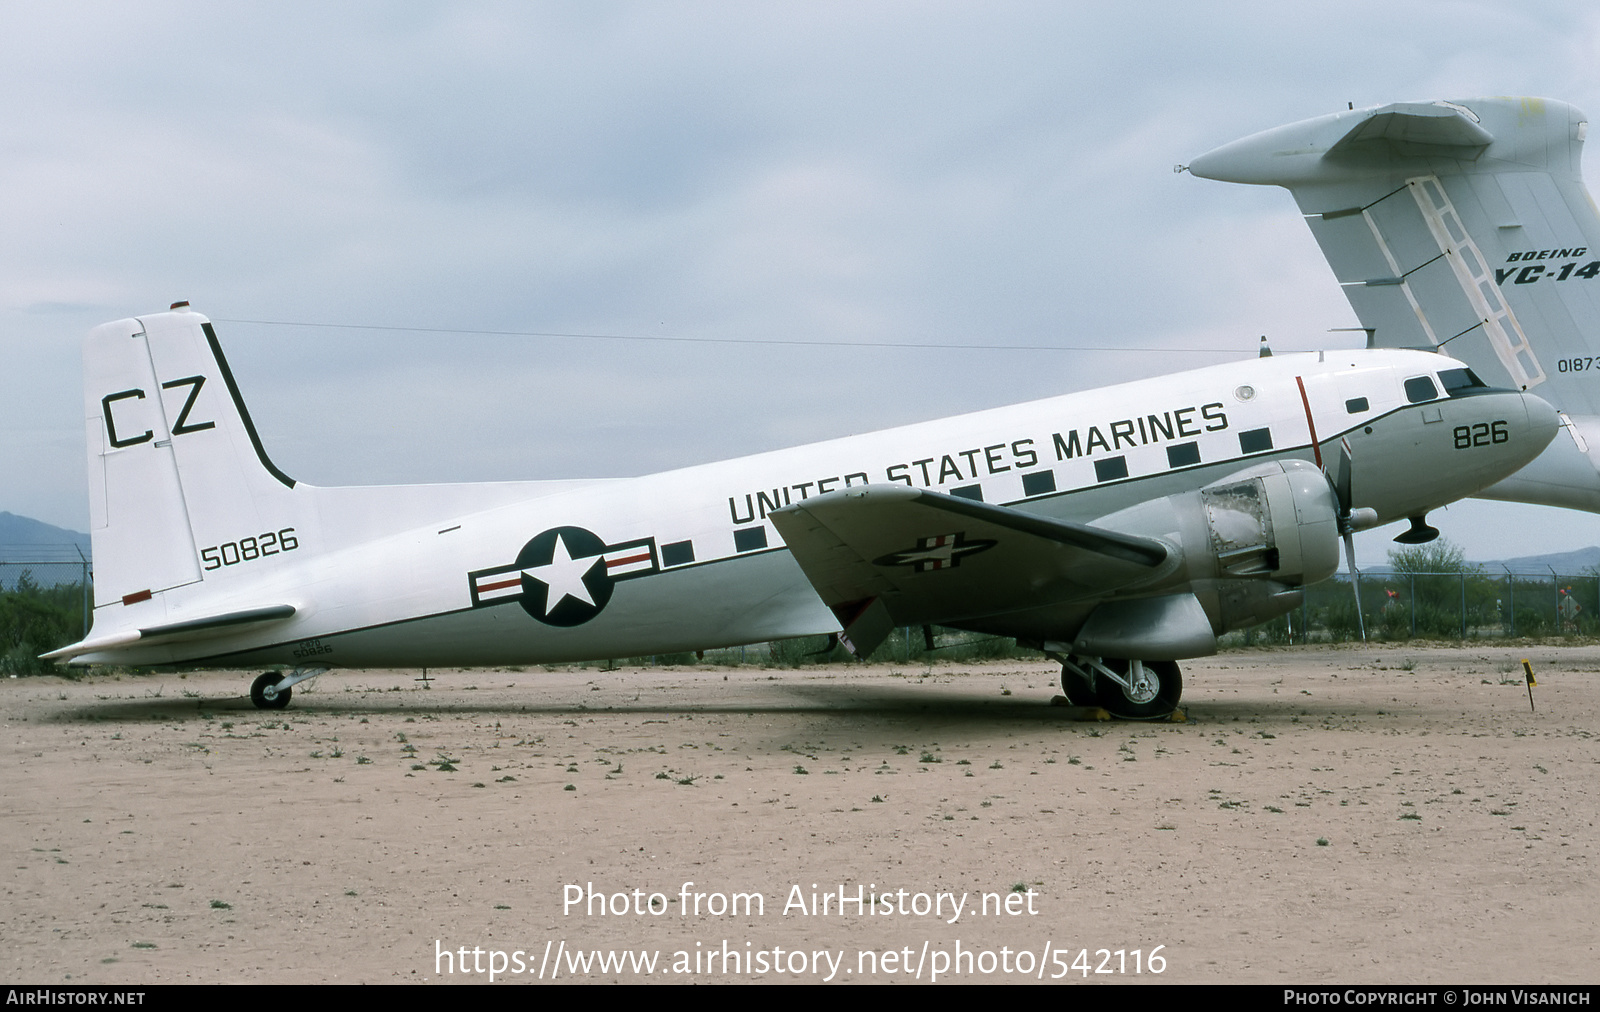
1187, 98, 1600, 512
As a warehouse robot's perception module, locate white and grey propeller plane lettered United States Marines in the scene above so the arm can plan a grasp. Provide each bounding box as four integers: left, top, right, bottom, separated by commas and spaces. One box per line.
45, 303, 1557, 717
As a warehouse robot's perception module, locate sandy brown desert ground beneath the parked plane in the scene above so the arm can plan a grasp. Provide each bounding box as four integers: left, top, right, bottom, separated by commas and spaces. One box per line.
0, 644, 1600, 983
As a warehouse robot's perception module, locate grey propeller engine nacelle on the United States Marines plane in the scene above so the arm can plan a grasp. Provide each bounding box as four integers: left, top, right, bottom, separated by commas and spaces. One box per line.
1074, 460, 1339, 660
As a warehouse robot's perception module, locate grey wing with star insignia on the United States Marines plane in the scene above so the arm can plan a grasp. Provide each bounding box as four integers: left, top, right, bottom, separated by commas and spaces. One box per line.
768, 485, 1168, 657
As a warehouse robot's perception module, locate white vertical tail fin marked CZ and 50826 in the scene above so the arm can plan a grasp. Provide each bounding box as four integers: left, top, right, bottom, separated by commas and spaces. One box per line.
83, 303, 315, 611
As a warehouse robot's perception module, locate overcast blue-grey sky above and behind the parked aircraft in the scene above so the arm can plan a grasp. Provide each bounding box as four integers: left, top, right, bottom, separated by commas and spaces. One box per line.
0, 0, 1600, 562
